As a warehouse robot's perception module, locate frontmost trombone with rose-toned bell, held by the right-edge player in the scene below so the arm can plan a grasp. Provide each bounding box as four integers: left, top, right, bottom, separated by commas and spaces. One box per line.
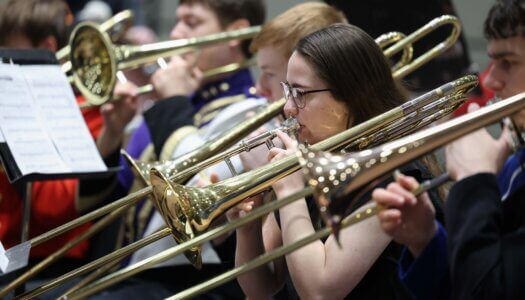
71, 89, 525, 299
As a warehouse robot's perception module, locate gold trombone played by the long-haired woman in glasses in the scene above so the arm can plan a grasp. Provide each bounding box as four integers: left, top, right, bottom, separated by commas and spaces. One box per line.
15, 76, 477, 297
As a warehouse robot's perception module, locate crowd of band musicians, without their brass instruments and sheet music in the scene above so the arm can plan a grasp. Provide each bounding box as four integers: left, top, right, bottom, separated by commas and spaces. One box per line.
0, 0, 525, 299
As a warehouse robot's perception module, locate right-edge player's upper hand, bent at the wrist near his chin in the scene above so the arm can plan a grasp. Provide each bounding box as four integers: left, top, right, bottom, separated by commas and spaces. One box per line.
445, 104, 511, 180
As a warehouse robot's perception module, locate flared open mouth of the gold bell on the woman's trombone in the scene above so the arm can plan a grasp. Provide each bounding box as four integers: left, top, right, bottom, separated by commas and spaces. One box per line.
150, 169, 202, 269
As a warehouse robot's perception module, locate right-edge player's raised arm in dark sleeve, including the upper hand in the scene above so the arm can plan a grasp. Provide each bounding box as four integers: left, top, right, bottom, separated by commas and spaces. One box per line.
445, 103, 525, 299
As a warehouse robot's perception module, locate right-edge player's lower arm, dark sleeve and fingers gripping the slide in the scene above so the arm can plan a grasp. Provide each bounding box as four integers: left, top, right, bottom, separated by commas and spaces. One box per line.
372, 174, 444, 299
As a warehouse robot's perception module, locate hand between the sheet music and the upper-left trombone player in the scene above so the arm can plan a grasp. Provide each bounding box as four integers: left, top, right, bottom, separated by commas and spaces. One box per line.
97, 82, 138, 157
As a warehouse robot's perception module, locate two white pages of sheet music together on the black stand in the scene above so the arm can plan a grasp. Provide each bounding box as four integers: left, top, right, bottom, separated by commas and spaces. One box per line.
0, 64, 107, 175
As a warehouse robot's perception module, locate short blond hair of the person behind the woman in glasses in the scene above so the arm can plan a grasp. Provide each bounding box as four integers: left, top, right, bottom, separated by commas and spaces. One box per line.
250, 2, 347, 58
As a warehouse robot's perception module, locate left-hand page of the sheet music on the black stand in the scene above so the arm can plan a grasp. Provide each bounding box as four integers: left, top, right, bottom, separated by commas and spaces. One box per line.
0, 64, 67, 174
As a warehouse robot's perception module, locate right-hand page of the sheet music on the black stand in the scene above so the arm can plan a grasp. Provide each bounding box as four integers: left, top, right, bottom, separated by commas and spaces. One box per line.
21, 65, 107, 172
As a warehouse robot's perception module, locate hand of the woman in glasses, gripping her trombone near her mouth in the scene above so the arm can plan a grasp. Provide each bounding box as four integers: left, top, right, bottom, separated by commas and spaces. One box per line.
268, 130, 305, 198
